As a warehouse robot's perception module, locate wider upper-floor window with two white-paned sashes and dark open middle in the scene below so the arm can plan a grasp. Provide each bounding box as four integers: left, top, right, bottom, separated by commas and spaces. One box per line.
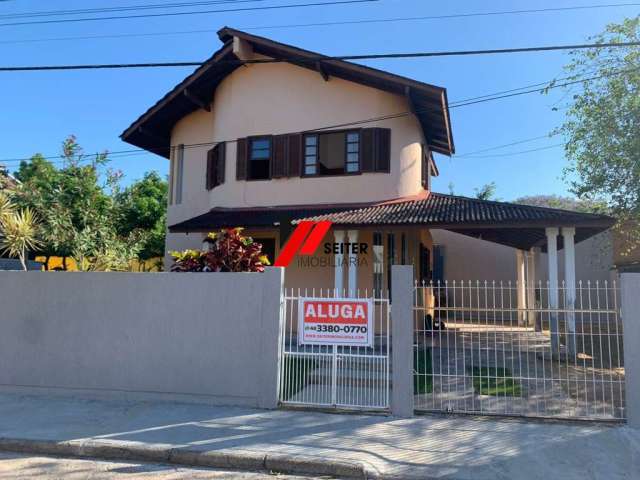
304, 132, 360, 175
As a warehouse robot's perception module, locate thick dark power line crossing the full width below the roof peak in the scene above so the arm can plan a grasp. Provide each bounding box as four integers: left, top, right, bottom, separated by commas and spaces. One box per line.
0, 41, 640, 72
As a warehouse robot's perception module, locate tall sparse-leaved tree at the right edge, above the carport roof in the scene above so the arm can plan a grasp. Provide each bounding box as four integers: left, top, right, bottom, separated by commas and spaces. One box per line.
547, 16, 640, 242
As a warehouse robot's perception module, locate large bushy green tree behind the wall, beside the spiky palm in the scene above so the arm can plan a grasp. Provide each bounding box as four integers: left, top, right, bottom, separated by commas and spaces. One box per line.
15, 136, 164, 270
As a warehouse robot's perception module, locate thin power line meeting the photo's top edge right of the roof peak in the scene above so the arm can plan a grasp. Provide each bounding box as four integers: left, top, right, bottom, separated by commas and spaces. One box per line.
0, 0, 380, 27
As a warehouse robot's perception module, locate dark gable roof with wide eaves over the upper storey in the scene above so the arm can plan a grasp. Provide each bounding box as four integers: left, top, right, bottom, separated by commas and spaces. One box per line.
120, 27, 455, 158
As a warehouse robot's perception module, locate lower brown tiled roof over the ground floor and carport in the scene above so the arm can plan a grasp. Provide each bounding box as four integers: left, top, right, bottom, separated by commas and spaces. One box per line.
169, 193, 615, 249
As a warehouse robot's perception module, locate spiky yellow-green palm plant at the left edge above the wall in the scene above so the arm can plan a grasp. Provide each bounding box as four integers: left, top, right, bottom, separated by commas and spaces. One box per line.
0, 206, 40, 270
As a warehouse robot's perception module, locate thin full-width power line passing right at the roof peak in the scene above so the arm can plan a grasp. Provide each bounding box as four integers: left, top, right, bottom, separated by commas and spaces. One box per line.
0, 0, 640, 44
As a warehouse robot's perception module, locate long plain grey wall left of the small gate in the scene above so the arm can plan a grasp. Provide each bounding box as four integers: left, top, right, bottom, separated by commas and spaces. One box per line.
0, 268, 282, 408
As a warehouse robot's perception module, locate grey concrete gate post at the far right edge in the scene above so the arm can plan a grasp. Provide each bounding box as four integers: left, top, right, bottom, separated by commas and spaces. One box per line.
620, 273, 640, 429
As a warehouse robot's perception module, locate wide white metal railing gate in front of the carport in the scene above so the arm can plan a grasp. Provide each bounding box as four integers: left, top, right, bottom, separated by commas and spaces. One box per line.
414, 281, 625, 420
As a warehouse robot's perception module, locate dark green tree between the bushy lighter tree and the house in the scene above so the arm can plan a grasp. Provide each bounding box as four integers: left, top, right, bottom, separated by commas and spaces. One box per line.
115, 172, 169, 260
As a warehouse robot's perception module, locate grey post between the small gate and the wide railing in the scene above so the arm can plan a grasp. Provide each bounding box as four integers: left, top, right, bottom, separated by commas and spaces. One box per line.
391, 265, 414, 417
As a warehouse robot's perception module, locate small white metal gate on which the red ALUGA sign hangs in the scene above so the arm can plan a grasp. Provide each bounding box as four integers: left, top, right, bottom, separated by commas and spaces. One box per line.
278, 289, 391, 410
